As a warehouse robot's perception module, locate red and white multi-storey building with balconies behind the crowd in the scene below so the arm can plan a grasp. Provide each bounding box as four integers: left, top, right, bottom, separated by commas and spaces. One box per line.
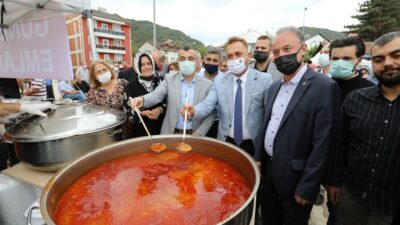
67, 10, 132, 70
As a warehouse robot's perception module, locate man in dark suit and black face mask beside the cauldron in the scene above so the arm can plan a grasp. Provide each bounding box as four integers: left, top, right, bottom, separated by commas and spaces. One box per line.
255, 27, 340, 225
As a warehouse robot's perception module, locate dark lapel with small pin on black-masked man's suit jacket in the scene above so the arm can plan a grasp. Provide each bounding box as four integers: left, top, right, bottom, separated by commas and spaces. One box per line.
278, 69, 312, 131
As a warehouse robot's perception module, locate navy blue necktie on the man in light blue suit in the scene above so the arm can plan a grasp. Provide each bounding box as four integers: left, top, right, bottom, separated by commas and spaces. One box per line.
233, 79, 243, 145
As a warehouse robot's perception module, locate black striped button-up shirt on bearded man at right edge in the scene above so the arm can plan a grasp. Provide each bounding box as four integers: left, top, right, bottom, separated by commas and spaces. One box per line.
328, 86, 400, 213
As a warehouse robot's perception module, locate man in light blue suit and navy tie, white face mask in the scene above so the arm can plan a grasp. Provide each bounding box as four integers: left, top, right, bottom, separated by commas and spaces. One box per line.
181, 37, 272, 156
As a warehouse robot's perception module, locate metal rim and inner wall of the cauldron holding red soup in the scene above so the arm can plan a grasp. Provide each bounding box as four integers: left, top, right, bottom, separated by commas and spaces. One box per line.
40, 135, 260, 225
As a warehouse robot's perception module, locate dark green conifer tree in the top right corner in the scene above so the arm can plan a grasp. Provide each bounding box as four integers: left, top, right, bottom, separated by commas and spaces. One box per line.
345, 0, 400, 41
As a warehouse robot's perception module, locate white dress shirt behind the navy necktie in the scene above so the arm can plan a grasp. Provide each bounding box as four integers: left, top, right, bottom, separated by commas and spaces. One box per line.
229, 68, 252, 140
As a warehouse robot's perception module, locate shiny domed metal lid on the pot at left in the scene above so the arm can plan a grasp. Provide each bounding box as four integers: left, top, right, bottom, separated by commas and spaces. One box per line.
5, 103, 126, 142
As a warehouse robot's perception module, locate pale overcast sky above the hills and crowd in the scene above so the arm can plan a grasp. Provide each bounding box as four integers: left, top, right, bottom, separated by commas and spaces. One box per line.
91, 0, 365, 45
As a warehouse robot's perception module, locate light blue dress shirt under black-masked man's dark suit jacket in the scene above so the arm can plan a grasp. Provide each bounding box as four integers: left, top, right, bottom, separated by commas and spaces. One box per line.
264, 65, 307, 156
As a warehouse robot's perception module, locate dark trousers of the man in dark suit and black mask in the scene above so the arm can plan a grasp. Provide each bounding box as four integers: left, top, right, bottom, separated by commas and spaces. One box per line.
261, 158, 313, 225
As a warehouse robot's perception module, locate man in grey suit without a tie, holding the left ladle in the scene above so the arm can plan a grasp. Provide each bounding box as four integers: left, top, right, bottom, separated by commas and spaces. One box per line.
131, 47, 215, 136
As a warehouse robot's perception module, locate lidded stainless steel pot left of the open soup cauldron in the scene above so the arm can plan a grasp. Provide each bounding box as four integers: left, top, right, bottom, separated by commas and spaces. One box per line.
6, 103, 126, 171
